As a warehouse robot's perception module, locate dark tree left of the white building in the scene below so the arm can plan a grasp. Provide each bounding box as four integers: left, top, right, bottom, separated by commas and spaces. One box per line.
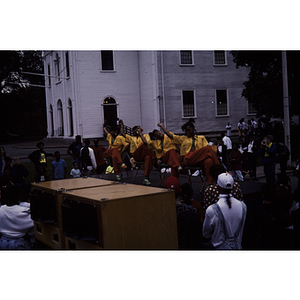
0, 51, 46, 141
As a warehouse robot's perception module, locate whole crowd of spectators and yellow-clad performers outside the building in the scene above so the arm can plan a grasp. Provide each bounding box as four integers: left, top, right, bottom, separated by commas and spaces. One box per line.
0, 119, 299, 250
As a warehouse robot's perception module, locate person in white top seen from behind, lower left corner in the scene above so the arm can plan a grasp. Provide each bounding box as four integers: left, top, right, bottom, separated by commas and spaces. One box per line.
0, 185, 34, 250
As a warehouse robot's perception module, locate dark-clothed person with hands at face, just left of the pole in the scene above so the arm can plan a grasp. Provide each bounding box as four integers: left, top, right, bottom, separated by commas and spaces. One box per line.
258, 135, 277, 183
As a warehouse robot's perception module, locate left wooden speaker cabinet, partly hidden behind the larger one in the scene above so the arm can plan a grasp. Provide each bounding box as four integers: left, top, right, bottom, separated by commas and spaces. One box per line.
31, 177, 114, 249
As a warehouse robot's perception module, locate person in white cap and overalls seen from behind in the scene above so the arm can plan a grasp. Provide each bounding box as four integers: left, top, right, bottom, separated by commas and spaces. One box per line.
202, 173, 247, 250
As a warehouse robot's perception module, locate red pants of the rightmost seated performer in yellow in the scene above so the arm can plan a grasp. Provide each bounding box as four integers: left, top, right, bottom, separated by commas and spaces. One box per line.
184, 146, 220, 184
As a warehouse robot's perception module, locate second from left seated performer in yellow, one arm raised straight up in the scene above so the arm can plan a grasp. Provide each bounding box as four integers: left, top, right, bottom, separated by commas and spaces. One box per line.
119, 120, 156, 185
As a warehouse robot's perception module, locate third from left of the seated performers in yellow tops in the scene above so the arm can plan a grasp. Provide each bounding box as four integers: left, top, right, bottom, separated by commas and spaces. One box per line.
148, 124, 182, 177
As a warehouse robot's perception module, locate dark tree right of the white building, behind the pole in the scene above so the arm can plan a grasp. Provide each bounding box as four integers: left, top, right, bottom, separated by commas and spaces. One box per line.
231, 51, 300, 117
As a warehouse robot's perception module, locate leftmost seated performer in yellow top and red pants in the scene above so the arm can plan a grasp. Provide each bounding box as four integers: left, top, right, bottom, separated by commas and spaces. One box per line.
104, 127, 127, 181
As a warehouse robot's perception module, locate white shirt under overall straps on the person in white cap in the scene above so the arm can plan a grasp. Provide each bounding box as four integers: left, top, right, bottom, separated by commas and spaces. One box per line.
202, 194, 246, 247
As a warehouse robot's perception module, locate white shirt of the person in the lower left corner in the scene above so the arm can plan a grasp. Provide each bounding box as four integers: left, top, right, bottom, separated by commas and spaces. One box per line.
0, 205, 34, 238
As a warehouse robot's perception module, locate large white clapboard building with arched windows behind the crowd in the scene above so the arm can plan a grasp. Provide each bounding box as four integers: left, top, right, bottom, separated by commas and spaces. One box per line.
44, 50, 255, 139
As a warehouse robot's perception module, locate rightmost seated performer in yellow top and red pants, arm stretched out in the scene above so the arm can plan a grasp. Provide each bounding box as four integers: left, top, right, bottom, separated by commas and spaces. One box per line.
158, 119, 220, 185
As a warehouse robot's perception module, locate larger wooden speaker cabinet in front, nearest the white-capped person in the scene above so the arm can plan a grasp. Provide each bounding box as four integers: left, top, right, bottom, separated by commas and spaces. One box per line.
62, 184, 178, 250
